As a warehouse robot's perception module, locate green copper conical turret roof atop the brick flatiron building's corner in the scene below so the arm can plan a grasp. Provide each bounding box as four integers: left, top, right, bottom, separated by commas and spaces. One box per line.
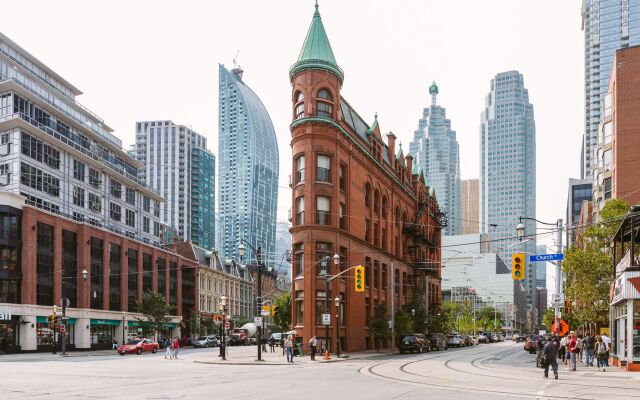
289, 3, 344, 83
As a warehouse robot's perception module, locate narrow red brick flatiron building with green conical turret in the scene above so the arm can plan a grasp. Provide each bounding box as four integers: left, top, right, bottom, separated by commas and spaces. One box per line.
290, 5, 442, 351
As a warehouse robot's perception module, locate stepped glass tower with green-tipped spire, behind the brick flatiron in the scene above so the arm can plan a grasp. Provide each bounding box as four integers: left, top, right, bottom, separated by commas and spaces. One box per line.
409, 82, 462, 235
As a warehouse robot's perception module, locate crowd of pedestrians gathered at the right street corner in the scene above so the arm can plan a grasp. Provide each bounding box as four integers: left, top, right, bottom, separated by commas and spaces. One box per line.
536, 331, 611, 379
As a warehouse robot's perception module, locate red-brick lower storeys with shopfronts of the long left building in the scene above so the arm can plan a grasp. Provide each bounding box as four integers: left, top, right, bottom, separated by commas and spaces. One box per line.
0, 192, 198, 351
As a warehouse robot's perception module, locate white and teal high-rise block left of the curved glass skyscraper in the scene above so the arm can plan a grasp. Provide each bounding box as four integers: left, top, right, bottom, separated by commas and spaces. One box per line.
135, 121, 216, 249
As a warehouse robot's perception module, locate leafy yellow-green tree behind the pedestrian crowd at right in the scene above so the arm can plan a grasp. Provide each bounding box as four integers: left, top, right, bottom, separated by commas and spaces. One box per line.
562, 199, 629, 326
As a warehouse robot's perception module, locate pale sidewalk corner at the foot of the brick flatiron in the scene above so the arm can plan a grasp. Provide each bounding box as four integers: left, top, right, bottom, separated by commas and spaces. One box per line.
193, 346, 391, 365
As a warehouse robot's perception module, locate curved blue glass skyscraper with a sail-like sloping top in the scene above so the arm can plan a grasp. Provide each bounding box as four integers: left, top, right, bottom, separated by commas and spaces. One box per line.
218, 65, 280, 262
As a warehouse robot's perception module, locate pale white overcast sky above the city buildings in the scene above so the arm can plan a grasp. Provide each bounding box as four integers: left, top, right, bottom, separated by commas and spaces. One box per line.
0, 0, 584, 262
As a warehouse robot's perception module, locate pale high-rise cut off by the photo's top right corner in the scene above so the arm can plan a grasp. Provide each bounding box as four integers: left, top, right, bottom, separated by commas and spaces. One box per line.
581, 0, 640, 179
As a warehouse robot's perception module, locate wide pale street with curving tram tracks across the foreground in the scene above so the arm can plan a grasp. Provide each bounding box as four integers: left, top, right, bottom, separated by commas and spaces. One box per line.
0, 342, 640, 399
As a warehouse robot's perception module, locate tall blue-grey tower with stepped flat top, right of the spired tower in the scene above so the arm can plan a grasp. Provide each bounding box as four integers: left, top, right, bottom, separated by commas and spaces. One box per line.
480, 71, 537, 324
